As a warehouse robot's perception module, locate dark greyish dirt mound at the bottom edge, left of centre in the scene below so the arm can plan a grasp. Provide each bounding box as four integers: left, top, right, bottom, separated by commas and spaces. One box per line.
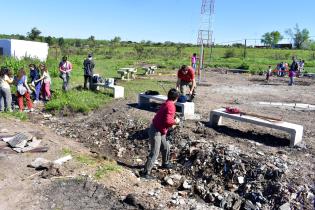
41, 179, 141, 210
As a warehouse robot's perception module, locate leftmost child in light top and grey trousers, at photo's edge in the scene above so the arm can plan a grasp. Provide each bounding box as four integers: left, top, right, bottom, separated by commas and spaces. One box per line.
0, 67, 13, 112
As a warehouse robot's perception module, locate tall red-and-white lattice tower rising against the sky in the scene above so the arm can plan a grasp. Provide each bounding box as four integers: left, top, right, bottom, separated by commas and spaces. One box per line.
197, 0, 215, 83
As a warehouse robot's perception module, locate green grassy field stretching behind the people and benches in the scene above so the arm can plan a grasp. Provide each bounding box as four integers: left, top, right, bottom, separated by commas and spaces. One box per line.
0, 46, 315, 113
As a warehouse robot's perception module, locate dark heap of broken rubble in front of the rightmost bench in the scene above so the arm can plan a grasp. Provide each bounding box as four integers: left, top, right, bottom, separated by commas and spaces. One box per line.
176, 135, 314, 209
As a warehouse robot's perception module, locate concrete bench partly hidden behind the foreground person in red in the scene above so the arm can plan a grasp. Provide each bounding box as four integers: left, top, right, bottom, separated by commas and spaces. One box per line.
138, 93, 195, 119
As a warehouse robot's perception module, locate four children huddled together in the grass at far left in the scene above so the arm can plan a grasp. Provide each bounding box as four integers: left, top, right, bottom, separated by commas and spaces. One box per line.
0, 63, 51, 112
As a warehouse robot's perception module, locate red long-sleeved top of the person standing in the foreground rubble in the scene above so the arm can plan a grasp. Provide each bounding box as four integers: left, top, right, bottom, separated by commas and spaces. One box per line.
152, 100, 176, 135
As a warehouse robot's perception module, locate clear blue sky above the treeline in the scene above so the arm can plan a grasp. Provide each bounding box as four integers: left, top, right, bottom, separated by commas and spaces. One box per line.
0, 0, 315, 43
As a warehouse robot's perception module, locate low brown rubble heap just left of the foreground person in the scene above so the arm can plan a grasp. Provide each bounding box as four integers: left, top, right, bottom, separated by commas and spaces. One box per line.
47, 109, 148, 158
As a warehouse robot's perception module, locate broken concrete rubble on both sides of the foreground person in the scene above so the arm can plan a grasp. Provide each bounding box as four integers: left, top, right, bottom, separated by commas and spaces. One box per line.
47, 110, 315, 210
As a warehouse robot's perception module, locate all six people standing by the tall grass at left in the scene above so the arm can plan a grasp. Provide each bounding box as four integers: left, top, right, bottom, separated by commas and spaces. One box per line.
0, 54, 95, 112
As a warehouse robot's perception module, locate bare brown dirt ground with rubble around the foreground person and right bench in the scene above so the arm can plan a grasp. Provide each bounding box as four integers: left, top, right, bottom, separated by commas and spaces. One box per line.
0, 69, 315, 209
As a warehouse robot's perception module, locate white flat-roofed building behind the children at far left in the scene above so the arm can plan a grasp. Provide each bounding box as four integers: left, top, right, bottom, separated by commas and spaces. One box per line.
0, 39, 49, 61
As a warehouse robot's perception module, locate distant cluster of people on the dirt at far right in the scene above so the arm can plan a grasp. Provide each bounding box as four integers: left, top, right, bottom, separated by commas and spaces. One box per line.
266, 56, 304, 85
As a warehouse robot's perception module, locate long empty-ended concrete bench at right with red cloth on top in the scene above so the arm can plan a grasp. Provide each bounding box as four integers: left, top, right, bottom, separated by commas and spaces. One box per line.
209, 108, 303, 147
